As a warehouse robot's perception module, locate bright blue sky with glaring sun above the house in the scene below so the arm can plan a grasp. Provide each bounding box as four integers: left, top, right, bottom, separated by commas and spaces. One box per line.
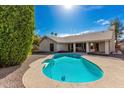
35, 5, 124, 36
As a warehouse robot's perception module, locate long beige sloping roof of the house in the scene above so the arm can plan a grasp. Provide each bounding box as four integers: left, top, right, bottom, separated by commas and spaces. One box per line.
42, 31, 113, 43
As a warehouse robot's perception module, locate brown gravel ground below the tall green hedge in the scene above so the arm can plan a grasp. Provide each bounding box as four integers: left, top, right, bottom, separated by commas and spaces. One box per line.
0, 54, 47, 88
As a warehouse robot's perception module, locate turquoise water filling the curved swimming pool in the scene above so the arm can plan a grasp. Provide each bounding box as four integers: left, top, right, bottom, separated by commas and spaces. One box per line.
42, 53, 104, 83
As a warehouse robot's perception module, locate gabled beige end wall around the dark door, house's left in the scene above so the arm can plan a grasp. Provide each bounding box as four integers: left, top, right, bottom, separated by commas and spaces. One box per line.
40, 38, 57, 52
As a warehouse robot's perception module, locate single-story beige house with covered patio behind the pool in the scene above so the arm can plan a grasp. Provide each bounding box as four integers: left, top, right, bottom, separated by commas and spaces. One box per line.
40, 26, 115, 54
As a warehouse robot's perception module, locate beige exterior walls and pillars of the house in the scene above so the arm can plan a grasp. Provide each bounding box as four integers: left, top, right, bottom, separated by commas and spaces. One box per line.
40, 30, 115, 54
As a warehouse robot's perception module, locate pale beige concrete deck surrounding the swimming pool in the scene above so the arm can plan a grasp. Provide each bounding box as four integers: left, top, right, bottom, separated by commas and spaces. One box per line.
22, 55, 124, 88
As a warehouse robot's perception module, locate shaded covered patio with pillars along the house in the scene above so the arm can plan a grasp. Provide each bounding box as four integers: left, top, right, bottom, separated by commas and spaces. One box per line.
68, 41, 109, 54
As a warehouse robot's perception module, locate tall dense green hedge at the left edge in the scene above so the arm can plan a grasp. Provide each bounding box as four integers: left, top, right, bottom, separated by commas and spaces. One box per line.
0, 6, 34, 67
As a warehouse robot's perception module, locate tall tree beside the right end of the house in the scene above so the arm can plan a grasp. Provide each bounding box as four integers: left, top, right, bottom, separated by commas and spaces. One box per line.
111, 18, 124, 51
